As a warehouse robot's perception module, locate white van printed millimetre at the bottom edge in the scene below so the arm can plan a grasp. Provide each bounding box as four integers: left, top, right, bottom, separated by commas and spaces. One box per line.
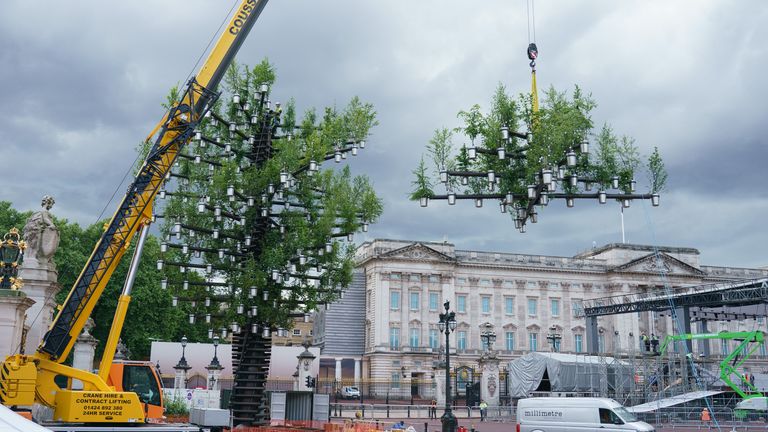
516, 398, 654, 432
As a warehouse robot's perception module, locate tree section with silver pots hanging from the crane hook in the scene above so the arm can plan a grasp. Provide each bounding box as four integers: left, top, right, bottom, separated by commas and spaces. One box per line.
411, 85, 667, 228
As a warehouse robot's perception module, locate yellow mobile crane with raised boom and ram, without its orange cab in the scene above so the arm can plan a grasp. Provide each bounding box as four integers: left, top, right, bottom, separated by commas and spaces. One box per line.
0, 0, 268, 423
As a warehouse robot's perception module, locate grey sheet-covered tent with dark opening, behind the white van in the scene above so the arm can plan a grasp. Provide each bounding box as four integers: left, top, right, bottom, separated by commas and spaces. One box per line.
507, 352, 634, 398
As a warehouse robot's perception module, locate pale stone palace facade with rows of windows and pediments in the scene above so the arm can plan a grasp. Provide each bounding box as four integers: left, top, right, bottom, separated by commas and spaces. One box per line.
315, 239, 768, 379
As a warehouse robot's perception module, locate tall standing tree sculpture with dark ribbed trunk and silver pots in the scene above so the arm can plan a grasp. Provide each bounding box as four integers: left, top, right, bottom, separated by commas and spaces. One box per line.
158, 61, 382, 424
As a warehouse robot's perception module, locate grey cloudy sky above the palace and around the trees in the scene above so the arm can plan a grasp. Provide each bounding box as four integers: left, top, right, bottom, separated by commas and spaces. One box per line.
0, 0, 768, 266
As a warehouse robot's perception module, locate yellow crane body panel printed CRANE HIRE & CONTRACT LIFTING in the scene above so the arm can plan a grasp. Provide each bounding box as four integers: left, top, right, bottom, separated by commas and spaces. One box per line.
53, 390, 144, 423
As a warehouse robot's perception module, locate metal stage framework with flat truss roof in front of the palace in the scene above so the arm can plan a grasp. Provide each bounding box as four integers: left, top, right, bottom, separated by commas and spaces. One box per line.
552, 278, 768, 406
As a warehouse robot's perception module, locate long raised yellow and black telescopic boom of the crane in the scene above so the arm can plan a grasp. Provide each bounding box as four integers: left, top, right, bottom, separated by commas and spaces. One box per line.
38, 0, 267, 362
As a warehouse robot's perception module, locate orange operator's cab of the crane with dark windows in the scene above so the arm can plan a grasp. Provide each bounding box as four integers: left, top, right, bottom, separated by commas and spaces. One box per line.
107, 360, 163, 422
